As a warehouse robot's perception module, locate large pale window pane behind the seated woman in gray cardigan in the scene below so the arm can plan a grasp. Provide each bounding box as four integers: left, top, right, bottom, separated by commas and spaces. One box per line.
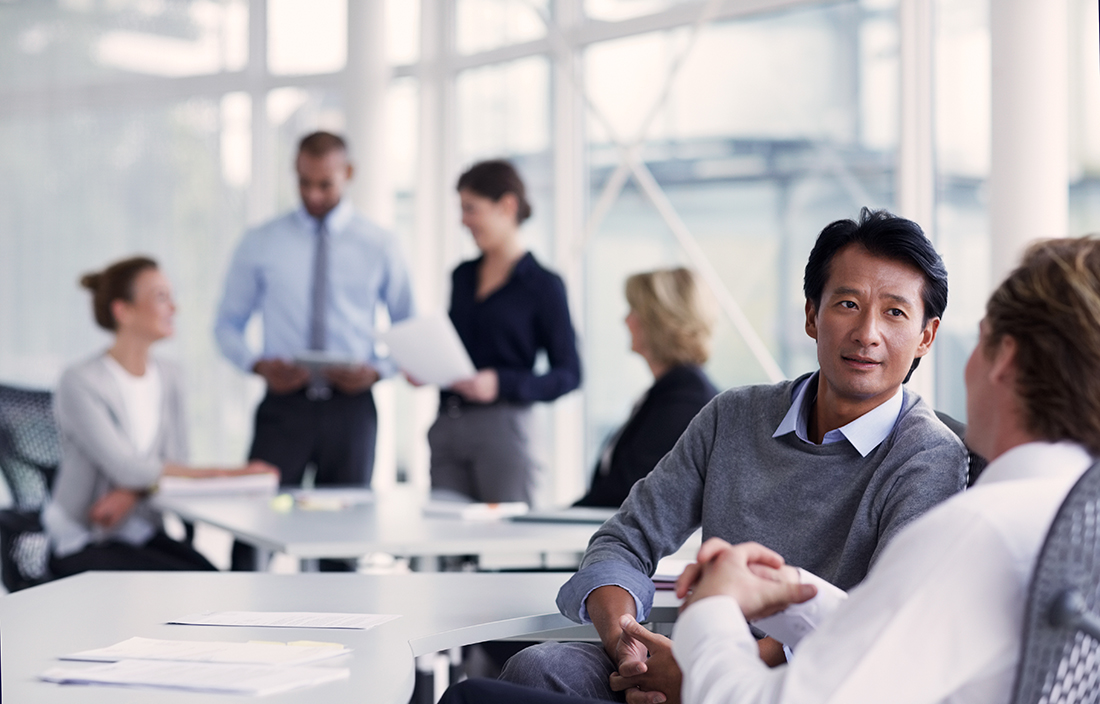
0, 97, 257, 463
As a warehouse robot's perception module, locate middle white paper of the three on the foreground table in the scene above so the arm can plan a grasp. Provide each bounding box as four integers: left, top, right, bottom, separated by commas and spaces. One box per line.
62, 638, 351, 667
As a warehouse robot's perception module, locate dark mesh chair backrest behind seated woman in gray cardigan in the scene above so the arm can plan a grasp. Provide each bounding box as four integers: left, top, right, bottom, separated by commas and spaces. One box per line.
0, 385, 62, 509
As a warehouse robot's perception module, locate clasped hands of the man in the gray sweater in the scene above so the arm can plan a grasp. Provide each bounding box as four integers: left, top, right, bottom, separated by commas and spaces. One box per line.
611, 616, 683, 704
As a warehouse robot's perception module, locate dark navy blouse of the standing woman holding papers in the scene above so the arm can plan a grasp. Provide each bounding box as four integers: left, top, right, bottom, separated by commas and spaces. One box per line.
442, 252, 581, 404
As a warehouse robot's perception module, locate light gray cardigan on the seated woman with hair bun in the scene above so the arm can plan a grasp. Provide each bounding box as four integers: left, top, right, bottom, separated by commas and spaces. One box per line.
43, 354, 187, 557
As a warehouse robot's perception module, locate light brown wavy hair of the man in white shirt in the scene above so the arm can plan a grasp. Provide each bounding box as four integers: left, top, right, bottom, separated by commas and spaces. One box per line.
983, 235, 1100, 454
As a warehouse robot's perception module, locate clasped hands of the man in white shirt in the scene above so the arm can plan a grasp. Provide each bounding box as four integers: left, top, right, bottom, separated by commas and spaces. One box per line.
677, 538, 817, 620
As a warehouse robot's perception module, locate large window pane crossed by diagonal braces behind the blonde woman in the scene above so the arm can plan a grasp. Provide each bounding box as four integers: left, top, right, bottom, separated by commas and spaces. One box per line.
584, 2, 898, 466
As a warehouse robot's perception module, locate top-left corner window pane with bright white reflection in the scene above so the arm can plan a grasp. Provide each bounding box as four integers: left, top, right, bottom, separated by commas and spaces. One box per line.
0, 0, 249, 89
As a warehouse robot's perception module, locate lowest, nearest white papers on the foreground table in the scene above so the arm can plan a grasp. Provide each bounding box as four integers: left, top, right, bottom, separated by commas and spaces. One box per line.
39, 660, 351, 696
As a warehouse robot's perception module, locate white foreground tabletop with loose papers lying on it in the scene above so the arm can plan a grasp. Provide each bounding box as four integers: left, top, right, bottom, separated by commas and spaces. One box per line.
0, 572, 675, 704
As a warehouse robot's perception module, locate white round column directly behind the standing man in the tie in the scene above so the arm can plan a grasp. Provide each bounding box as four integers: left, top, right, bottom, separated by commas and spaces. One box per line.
344, 0, 397, 491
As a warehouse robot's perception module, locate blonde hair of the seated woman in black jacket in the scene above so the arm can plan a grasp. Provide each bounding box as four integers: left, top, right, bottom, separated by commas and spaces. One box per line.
626, 267, 715, 365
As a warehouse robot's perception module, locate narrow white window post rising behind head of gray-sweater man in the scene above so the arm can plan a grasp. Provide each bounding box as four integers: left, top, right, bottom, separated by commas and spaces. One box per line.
897, 0, 936, 404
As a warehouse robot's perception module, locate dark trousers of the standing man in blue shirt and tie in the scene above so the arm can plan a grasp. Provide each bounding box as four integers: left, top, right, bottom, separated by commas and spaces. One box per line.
232, 389, 378, 570
